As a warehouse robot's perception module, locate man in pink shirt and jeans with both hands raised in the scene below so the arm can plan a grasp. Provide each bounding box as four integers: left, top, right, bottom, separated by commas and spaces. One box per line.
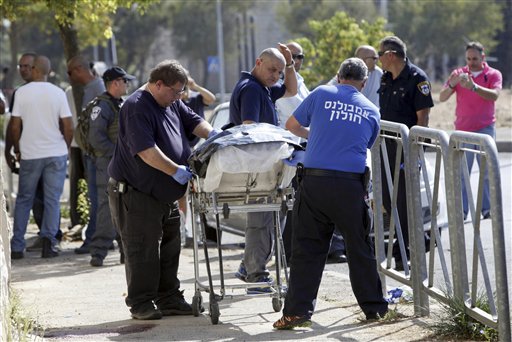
439, 42, 503, 220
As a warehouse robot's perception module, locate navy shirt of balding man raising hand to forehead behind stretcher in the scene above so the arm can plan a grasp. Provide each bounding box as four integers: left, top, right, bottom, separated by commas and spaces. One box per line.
229, 71, 286, 125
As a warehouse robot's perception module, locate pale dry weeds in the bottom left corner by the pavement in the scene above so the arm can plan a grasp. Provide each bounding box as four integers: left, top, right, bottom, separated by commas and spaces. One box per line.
7, 288, 44, 342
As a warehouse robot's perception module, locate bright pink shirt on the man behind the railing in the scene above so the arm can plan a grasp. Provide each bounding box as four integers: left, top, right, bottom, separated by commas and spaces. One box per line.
446, 63, 503, 132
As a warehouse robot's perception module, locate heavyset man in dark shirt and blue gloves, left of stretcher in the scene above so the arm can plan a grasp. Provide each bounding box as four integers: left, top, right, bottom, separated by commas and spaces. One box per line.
107, 60, 217, 320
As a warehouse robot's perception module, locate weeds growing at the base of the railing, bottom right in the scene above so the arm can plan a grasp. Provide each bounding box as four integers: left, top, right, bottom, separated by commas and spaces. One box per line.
431, 293, 499, 342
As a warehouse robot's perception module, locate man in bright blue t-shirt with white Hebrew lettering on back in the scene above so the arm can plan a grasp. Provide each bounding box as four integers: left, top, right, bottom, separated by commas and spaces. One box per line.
274, 58, 388, 329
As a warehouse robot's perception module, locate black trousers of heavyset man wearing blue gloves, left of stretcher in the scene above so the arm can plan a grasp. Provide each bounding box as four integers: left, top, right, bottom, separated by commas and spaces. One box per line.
108, 181, 181, 311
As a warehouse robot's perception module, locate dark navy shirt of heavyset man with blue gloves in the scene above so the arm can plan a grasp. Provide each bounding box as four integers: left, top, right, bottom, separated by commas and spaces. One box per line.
108, 89, 203, 203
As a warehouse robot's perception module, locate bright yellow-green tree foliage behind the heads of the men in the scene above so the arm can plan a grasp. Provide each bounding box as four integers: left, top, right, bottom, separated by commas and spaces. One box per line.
297, 12, 391, 87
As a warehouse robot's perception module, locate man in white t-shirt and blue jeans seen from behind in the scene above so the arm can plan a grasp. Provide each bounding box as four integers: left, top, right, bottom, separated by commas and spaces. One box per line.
11, 56, 73, 259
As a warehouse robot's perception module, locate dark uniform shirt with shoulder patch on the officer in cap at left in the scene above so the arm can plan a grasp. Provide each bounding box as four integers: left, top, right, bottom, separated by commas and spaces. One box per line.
88, 92, 123, 157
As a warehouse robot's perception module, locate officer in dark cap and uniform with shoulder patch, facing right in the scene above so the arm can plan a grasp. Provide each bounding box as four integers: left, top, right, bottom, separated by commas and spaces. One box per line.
87, 66, 135, 267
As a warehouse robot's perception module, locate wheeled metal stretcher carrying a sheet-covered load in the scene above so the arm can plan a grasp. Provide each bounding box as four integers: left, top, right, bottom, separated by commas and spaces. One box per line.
189, 124, 296, 324
